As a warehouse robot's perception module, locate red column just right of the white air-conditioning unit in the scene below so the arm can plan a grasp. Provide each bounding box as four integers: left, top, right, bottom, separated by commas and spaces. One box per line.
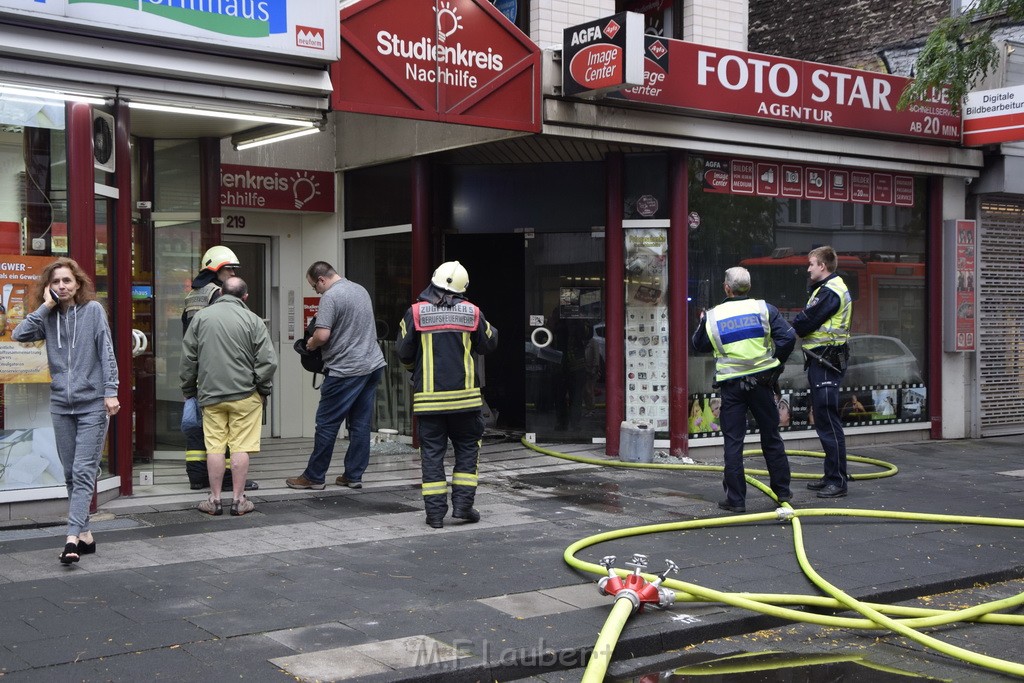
111, 102, 135, 496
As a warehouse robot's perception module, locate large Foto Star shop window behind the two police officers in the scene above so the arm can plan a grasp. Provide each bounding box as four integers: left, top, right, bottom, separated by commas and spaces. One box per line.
688, 158, 928, 436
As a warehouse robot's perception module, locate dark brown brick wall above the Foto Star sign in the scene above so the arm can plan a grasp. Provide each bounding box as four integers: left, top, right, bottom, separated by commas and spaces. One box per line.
749, 0, 949, 71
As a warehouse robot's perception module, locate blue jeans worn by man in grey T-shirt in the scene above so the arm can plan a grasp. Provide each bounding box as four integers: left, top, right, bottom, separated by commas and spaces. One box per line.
302, 368, 384, 483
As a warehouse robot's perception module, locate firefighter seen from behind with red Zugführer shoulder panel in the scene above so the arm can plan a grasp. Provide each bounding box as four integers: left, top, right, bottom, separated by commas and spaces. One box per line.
397, 261, 498, 528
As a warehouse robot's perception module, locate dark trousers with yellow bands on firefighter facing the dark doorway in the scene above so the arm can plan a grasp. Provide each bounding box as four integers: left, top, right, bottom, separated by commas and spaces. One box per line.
416, 409, 483, 519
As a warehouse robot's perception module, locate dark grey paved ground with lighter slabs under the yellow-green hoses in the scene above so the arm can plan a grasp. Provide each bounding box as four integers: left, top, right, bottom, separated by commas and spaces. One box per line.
0, 438, 1024, 681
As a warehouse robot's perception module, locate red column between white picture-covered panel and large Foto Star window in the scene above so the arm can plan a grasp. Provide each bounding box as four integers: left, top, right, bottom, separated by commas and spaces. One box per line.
669, 151, 690, 457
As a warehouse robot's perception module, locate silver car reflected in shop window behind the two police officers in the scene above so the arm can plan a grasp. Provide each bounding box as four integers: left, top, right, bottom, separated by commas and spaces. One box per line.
779, 335, 924, 389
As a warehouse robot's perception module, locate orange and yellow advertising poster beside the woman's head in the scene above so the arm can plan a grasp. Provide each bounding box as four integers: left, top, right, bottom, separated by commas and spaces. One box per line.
0, 255, 53, 384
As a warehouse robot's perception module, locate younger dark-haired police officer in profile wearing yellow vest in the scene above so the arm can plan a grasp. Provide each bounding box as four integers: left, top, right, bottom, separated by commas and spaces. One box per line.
793, 246, 853, 498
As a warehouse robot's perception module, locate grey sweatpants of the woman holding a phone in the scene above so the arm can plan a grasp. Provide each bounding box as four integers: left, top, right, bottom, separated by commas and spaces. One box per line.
51, 411, 110, 536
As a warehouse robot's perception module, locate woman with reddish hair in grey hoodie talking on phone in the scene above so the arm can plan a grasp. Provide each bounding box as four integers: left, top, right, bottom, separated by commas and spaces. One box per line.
11, 258, 121, 564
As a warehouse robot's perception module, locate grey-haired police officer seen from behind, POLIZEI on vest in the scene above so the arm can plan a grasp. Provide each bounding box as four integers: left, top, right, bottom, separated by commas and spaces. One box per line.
691, 266, 797, 512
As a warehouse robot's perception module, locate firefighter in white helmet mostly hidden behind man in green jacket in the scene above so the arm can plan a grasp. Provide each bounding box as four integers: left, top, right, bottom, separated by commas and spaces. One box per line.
181, 245, 253, 490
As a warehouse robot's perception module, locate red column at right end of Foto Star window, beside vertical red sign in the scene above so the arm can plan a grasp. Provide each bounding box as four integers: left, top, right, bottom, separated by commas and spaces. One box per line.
927, 176, 945, 438
